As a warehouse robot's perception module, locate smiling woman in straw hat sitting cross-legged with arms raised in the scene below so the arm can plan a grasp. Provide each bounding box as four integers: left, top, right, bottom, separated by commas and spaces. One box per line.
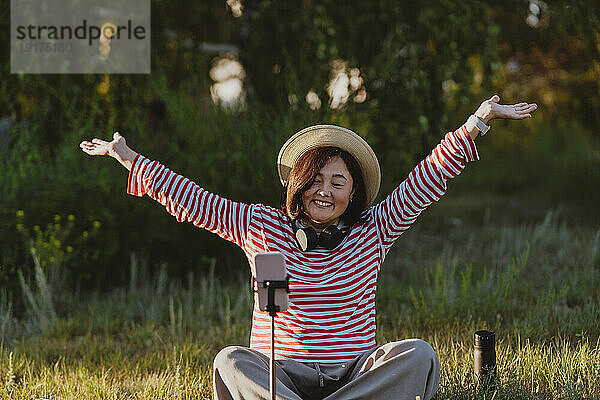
80, 96, 537, 400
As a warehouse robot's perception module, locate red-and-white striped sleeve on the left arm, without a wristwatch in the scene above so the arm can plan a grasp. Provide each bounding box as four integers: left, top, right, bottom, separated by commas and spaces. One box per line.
127, 155, 253, 247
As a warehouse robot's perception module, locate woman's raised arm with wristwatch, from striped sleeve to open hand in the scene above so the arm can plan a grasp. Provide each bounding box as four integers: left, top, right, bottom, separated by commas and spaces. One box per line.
373, 95, 537, 256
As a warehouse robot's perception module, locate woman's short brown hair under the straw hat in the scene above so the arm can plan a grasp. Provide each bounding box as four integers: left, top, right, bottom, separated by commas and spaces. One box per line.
281, 146, 367, 226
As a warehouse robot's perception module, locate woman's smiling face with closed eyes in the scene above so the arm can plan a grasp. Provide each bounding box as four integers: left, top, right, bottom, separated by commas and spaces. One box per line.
302, 157, 354, 230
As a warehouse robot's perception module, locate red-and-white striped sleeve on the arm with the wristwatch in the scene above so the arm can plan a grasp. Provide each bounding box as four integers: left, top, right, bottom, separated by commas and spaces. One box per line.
373, 125, 479, 257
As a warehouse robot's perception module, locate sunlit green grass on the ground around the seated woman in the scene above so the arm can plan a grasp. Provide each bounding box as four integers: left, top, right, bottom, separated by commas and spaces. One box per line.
0, 205, 600, 399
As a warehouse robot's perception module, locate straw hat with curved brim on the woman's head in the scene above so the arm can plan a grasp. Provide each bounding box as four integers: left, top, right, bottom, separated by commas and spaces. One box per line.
277, 125, 381, 204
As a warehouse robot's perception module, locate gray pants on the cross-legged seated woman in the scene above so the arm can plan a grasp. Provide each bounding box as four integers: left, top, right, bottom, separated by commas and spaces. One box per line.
213, 339, 440, 400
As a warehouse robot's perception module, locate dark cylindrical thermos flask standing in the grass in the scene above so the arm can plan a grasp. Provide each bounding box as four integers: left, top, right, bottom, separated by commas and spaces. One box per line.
473, 331, 496, 391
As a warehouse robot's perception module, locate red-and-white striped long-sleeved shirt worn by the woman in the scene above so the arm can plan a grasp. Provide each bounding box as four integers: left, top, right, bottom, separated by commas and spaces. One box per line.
127, 126, 479, 363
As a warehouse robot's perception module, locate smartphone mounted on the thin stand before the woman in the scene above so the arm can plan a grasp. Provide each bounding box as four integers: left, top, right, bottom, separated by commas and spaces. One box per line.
254, 251, 289, 311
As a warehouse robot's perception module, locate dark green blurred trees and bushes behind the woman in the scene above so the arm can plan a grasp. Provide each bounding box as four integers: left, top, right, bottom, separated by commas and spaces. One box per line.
0, 0, 600, 314
